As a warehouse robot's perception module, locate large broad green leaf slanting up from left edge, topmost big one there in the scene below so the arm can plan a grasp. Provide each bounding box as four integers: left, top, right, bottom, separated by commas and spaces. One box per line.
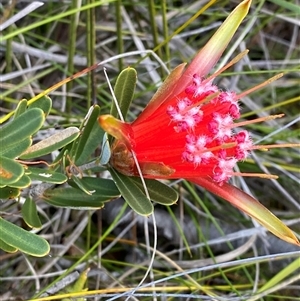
0, 108, 45, 152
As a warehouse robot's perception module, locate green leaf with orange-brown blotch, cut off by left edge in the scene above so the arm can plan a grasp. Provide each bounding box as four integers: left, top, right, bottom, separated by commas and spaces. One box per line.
0, 157, 24, 186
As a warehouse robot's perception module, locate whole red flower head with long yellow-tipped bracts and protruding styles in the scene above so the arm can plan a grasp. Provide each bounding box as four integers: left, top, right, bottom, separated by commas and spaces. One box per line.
99, 0, 299, 244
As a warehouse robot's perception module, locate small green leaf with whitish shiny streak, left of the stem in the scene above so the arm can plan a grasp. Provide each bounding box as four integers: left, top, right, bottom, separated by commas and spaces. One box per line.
25, 166, 68, 184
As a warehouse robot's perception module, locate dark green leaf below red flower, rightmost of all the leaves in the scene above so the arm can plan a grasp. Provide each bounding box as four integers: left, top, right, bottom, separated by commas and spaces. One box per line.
131, 177, 178, 206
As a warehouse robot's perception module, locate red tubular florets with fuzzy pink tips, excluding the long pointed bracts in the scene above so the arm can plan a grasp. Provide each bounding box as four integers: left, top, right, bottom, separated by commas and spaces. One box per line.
106, 70, 252, 184
